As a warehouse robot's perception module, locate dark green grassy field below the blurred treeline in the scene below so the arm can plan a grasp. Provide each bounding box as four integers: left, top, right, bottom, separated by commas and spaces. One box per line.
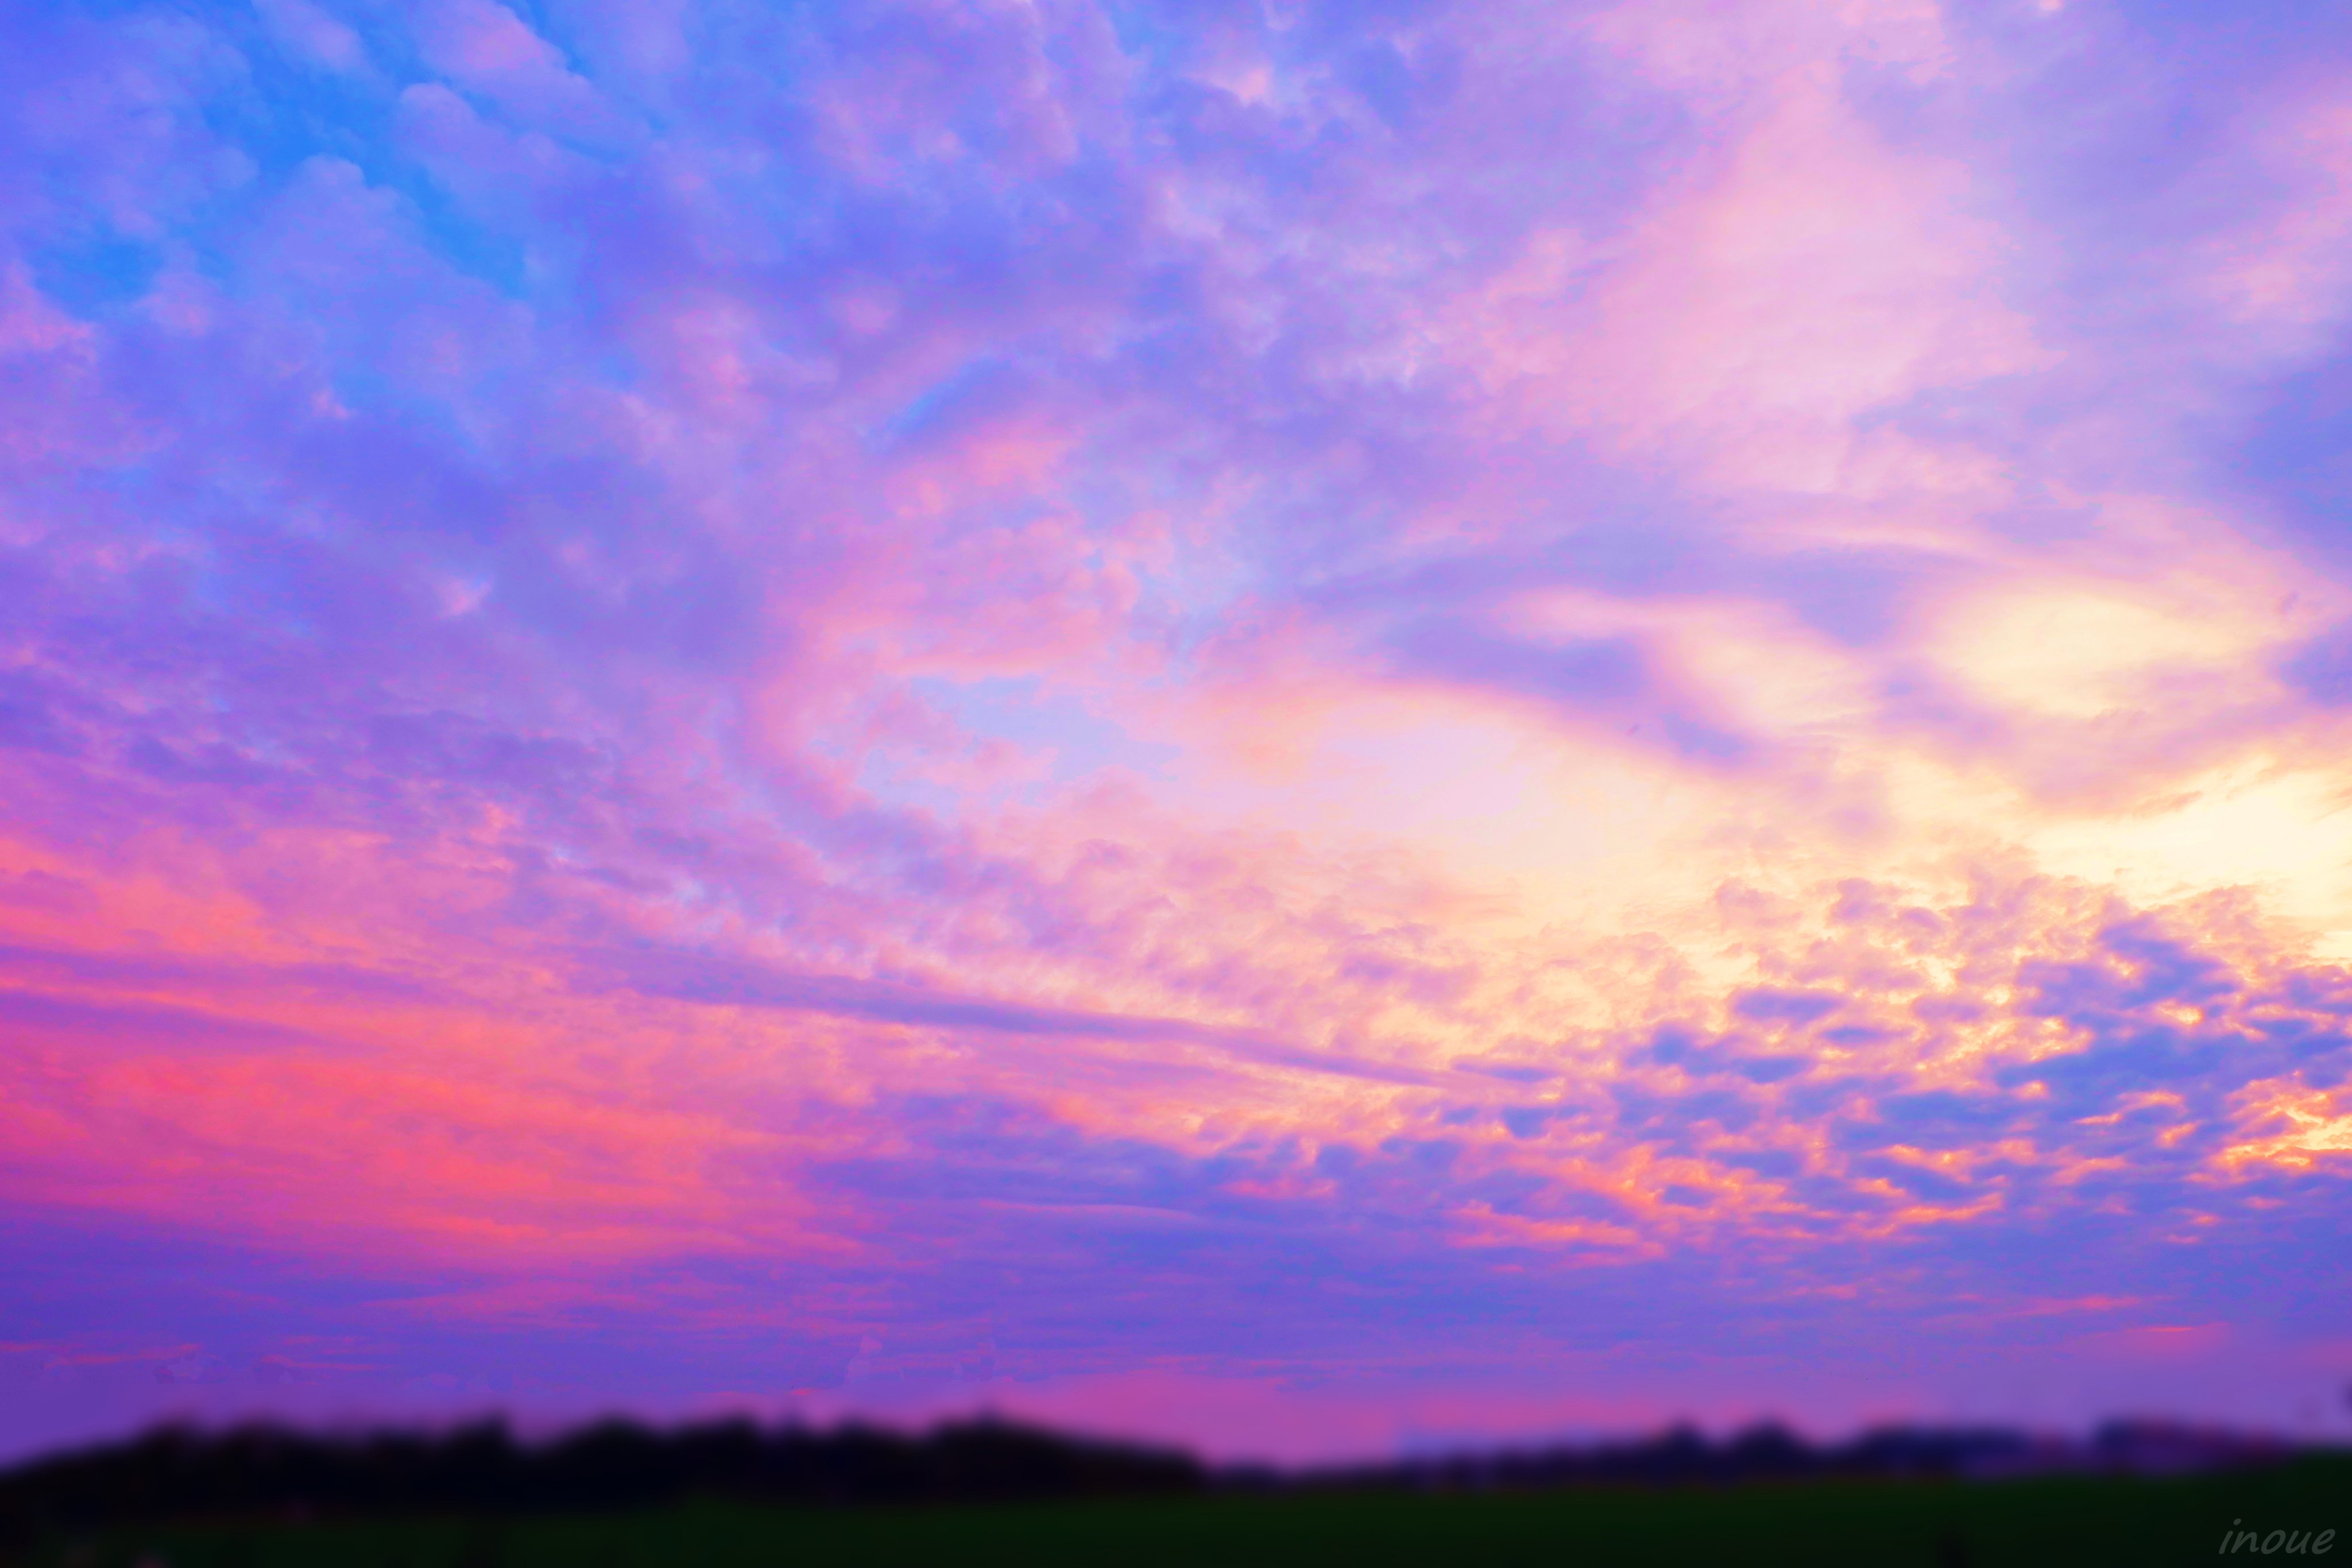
18, 1455, 2352, 1568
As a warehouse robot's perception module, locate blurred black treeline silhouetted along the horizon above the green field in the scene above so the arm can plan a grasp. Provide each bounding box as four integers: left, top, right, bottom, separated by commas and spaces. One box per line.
0, 1420, 2291, 1540
